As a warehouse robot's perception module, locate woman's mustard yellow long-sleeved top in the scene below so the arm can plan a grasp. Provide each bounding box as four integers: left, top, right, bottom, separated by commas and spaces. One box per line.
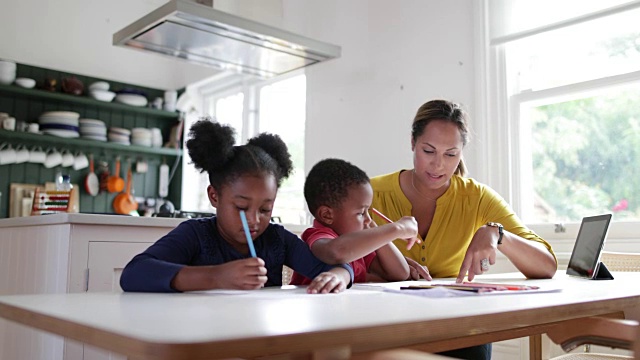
371, 170, 557, 278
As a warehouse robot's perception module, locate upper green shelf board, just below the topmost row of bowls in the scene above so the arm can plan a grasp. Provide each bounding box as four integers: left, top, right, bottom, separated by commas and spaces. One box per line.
0, 84, 180, 120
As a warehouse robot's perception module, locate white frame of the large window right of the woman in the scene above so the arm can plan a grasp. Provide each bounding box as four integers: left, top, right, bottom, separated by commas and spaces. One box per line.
474, 0, 640, 229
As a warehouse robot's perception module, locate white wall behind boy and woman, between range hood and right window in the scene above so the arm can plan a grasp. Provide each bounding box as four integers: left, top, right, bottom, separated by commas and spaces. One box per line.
283, 0, 475, 176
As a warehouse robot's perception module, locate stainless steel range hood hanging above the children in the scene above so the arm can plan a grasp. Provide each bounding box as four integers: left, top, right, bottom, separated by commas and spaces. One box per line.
113, 0, 340, 78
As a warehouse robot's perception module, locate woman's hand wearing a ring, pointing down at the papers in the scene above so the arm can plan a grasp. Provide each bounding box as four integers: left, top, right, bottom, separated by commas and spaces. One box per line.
456, 225, 498, 283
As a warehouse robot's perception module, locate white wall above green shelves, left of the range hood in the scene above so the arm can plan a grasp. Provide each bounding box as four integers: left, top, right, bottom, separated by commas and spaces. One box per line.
0, 0, 218, 89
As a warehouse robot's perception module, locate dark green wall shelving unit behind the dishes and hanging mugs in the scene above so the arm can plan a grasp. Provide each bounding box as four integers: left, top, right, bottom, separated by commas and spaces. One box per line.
0, 64, 182, 218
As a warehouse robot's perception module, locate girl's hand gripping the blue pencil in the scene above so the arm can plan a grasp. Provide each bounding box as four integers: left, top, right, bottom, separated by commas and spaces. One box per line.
215, 257, 267, 290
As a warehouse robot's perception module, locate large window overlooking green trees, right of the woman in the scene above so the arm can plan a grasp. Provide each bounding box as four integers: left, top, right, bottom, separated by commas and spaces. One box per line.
489, 1, 640, 223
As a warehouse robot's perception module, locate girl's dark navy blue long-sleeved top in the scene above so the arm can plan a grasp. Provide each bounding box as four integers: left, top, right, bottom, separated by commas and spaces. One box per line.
120, 216, 353, 292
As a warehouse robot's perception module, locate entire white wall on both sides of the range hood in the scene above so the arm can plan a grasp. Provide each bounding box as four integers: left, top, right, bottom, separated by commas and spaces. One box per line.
0, 0, 477, 176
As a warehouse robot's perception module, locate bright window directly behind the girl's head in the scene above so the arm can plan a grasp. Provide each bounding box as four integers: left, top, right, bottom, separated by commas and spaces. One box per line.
182, 75, 306, 224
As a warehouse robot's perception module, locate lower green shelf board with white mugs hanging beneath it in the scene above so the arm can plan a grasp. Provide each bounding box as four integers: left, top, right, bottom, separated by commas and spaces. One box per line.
0, 129, 182, 157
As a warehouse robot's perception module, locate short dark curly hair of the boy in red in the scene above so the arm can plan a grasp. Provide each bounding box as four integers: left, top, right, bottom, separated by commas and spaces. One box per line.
304, 159, 369, 215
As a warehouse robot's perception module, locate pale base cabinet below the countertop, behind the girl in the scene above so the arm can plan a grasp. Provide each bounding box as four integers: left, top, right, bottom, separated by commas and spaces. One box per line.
0, 214, 185, 360
